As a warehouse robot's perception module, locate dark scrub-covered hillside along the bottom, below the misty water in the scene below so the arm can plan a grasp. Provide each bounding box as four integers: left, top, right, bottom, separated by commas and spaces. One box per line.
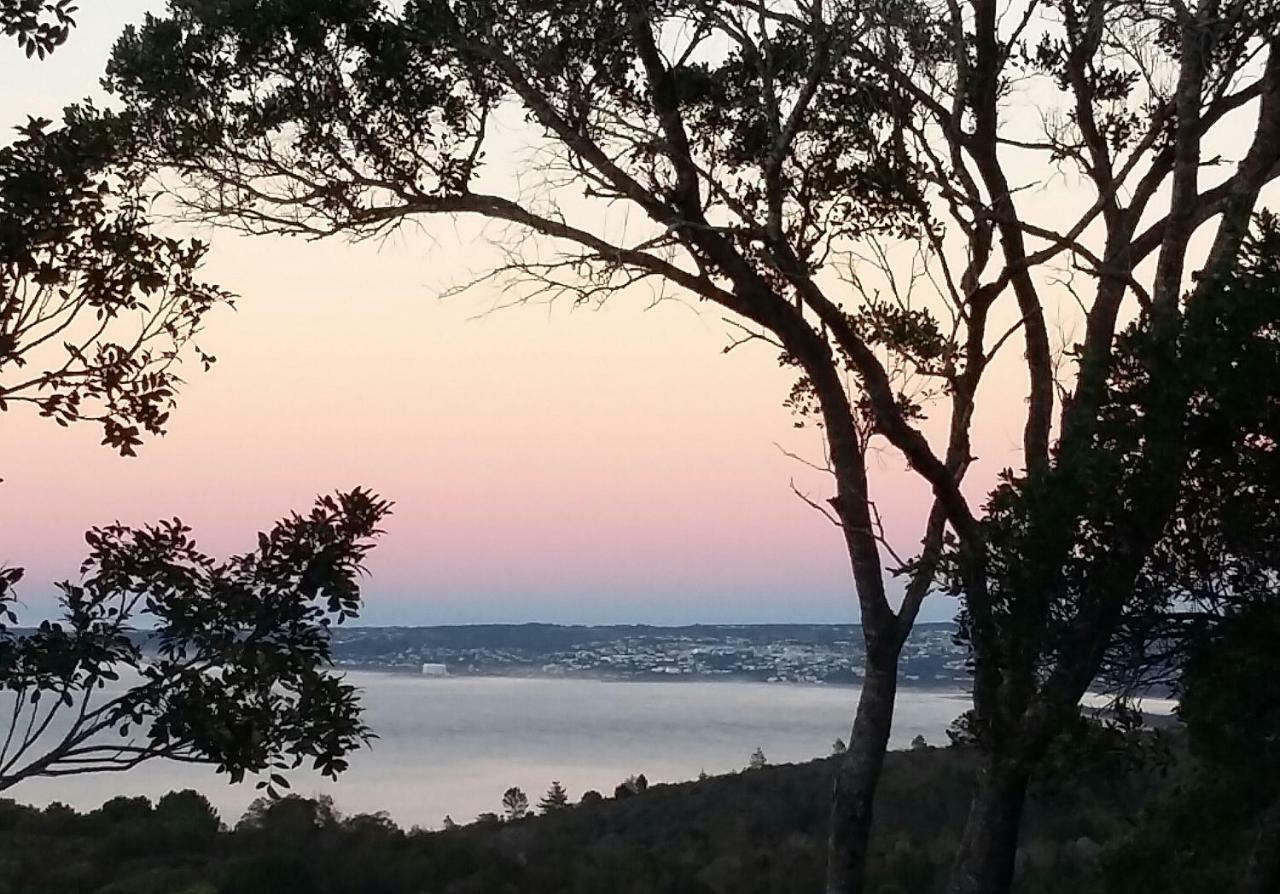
0, 727, 1248, 894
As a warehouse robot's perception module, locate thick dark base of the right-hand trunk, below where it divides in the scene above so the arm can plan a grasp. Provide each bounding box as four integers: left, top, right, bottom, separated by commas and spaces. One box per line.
947, 758, 1029, 894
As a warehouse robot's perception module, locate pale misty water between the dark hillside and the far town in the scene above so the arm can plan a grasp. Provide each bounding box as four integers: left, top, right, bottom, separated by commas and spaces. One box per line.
0, 672, 966, 827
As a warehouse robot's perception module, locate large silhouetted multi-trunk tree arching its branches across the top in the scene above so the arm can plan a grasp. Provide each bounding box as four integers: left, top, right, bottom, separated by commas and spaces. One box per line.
109, 0, 1280, 893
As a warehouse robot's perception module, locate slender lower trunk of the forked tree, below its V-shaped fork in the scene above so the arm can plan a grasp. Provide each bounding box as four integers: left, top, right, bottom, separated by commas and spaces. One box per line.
827, 651, 897, 894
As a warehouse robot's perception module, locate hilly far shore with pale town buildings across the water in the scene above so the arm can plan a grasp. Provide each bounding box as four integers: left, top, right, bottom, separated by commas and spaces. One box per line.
333, 624, 968, 688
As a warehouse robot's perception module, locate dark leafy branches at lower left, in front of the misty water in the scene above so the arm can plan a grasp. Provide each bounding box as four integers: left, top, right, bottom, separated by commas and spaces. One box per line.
0, 489, 389, 794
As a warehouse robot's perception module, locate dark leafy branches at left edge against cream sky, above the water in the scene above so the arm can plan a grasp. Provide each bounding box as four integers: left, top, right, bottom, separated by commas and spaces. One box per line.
0, 105, 230, 456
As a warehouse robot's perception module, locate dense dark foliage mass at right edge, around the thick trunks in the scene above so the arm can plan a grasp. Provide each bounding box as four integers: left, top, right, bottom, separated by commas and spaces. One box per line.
954, 215, 1280, 735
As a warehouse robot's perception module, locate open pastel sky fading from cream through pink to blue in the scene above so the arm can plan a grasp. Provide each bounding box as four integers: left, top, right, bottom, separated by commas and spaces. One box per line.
0, 0, 1024, 624
